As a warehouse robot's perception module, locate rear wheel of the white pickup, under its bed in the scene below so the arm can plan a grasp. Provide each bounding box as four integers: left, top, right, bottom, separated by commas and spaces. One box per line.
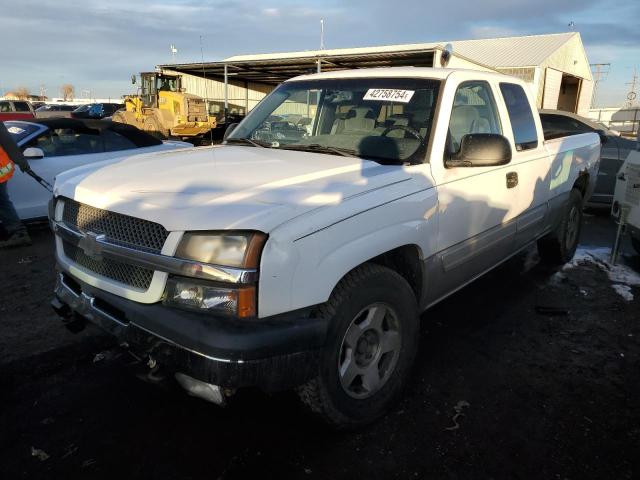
538, 188, 583, 265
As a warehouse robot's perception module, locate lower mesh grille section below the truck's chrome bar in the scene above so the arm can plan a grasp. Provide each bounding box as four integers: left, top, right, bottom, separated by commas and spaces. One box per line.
63, 242, 153, 290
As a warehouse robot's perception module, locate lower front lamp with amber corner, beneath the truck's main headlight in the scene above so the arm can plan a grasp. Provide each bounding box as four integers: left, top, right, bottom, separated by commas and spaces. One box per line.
163, 277, 256, 318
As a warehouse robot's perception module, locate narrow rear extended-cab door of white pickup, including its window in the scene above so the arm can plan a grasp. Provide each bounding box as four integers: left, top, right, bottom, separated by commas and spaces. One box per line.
499, 81, 551, 248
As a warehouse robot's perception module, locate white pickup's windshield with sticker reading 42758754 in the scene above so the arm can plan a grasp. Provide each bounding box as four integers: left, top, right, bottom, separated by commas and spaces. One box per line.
227, 78, 440, 163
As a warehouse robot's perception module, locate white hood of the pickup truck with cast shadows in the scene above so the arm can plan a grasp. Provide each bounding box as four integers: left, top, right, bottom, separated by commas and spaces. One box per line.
55, 146, 410, 232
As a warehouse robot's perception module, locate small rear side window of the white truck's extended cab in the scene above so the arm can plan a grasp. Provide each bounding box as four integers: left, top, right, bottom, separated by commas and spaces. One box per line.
500, 83, 538, 152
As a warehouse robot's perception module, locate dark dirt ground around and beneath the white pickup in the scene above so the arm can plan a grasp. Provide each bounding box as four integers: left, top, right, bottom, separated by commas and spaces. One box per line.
0, 216, 640, 479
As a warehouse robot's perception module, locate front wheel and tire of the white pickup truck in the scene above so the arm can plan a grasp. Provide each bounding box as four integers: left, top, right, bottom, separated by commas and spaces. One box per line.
297, 264, 419, 429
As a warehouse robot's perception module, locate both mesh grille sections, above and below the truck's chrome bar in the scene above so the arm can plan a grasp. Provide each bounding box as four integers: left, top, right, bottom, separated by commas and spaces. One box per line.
62, 199, 169, 290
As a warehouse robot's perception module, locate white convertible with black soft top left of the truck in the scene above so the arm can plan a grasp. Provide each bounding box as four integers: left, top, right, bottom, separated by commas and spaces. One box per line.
4, 118, 192, 220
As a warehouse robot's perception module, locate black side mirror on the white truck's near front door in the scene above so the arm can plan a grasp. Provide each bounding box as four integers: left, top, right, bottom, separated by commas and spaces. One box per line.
445, 133, 511, 168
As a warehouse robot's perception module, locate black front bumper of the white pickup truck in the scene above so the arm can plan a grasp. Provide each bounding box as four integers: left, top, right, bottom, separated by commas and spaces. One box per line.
52, 273, 327, 391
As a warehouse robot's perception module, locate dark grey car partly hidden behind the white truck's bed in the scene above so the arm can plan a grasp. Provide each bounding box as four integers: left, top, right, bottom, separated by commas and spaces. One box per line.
540, 110, 637, 207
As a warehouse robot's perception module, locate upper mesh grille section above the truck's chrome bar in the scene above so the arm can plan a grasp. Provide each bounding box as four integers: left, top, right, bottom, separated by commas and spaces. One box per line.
62, 199, 169, 253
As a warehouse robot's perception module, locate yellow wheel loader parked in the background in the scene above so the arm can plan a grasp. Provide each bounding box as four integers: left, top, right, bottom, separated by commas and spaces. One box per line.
112, 72, 216, 139
